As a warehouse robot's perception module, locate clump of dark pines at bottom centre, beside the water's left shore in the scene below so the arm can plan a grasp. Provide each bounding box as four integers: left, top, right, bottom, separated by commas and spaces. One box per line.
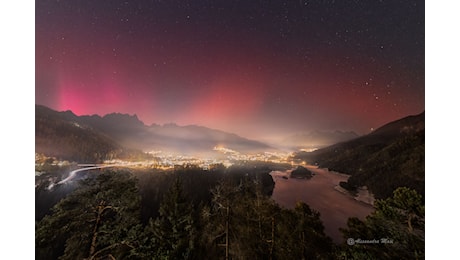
202, 179, 332, 259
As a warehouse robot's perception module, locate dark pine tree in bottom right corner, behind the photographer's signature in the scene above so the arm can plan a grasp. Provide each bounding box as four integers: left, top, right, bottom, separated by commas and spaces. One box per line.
341, 187, 425, 259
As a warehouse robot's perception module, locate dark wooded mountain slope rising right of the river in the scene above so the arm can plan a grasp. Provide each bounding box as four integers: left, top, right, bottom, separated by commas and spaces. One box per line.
295, 112, 425, 198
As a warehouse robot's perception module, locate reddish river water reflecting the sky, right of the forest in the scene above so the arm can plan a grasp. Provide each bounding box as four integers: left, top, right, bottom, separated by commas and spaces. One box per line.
270, 166, 374, 243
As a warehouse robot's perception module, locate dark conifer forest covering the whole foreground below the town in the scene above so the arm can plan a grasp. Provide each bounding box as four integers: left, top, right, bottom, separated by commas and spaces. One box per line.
35, 163, 424, 259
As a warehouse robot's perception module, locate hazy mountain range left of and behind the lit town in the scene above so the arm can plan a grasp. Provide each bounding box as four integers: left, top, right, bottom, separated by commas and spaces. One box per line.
35, 105, 275, 160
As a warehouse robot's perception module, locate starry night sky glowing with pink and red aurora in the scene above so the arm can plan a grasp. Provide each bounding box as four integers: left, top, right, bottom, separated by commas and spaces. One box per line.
35, 0, 425, 139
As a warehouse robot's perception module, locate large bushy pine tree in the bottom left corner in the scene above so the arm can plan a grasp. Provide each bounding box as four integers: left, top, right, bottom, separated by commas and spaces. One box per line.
35, 171, 140, 259
